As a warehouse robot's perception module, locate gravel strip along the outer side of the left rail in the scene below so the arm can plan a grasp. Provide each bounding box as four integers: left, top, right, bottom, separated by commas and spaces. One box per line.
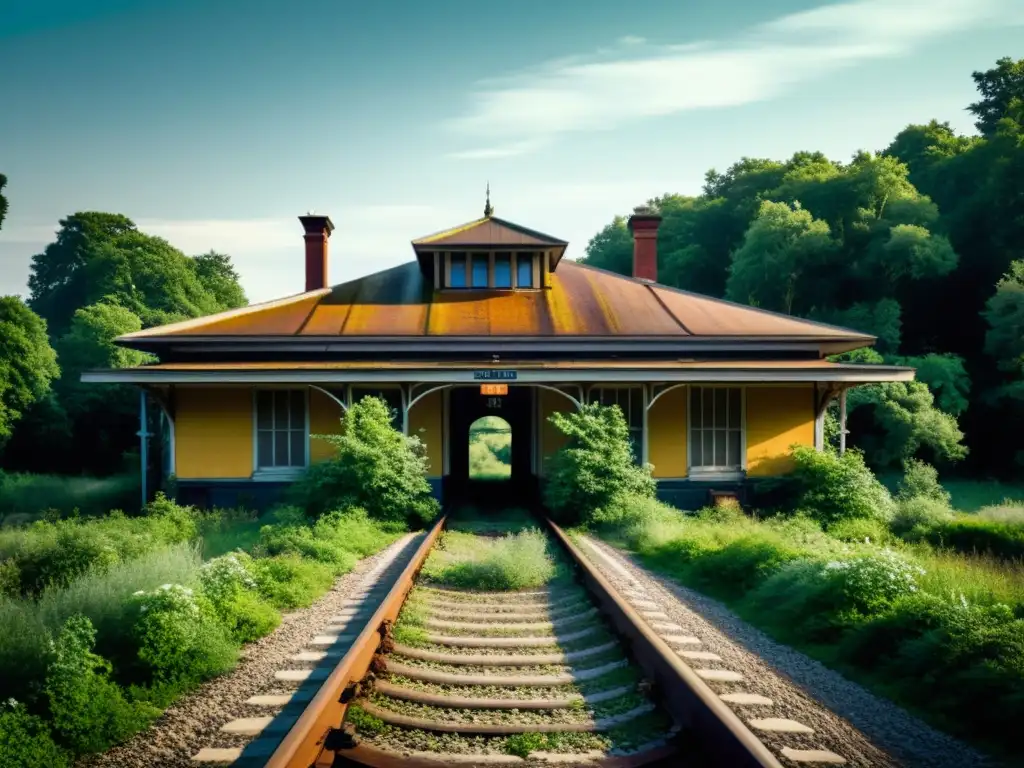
76, 534, 421, 768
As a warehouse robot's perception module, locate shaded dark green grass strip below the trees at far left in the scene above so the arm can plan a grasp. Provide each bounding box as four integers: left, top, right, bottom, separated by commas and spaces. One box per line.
0, 471, 139, 525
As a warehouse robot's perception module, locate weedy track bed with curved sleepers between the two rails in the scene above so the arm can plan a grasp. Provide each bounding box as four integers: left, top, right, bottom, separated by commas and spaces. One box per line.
346, 513, 673, 760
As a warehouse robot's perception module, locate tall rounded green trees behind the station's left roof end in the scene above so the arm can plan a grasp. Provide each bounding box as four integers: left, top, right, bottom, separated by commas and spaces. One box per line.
3, 211, 246, 472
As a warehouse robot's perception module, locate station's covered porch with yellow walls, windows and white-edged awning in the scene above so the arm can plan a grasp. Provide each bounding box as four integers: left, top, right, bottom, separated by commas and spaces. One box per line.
85, 359, 913, 508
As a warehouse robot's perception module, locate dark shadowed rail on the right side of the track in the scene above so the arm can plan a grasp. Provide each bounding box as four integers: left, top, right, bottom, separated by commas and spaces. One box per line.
548, 518, 782, 768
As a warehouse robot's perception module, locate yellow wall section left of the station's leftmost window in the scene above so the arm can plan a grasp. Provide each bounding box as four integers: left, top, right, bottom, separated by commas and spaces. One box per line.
174, 387, 253, 479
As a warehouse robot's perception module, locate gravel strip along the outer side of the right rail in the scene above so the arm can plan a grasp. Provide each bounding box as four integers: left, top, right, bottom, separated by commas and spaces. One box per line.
578, 537, 993, 768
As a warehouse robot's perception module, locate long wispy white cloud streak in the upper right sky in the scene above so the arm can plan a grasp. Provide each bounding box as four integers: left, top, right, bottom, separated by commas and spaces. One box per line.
447, 0, 1024, 160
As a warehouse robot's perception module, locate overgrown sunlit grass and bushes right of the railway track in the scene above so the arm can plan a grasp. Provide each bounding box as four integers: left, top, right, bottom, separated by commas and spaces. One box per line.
599, 500, 1024, 751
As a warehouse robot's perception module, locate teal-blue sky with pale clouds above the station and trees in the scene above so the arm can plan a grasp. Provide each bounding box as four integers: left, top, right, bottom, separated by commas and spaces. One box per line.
0, 0, 1024, 301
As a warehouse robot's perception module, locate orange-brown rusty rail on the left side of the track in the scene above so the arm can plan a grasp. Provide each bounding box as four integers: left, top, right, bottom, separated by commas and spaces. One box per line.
265, 516, 447, 768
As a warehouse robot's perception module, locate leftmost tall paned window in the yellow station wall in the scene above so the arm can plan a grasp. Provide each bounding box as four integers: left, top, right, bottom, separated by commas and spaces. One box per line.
256, 389, 309, 470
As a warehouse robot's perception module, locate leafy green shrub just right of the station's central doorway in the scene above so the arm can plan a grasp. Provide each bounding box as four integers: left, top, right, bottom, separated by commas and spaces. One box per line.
544, 403, 655, 522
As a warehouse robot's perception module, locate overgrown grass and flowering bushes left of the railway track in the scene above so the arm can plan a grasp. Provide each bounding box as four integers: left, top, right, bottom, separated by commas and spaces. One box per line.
0, 500, 398, 764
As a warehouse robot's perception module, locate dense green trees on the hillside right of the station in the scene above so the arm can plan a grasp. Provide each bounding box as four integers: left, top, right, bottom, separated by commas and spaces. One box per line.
584, 58, 1024, 472
